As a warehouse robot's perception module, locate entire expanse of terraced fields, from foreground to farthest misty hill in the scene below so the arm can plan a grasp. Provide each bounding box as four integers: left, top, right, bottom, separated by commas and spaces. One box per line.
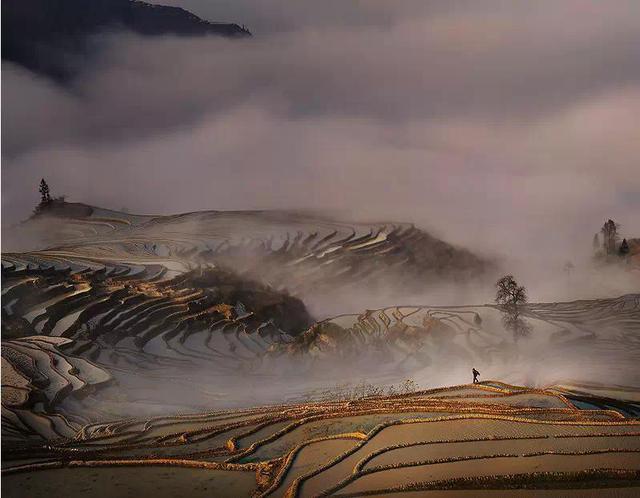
2, 203, 640, 498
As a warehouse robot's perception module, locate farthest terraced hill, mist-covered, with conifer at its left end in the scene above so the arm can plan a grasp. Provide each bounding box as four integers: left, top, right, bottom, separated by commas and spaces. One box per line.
3, 203, 492, 294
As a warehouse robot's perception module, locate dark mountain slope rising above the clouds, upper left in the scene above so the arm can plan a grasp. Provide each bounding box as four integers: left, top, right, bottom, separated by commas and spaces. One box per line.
2, 0, 251, 80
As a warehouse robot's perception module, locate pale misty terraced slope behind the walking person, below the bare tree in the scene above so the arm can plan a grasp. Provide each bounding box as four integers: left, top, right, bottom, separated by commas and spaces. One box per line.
264, 294, 640, 385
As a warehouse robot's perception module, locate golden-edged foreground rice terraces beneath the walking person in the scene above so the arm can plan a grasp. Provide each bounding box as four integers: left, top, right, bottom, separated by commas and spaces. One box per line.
2, 384, 640, 497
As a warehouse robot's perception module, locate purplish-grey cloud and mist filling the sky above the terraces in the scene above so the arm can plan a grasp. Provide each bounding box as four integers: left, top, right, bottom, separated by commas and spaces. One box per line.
2, 0, 640, 268
